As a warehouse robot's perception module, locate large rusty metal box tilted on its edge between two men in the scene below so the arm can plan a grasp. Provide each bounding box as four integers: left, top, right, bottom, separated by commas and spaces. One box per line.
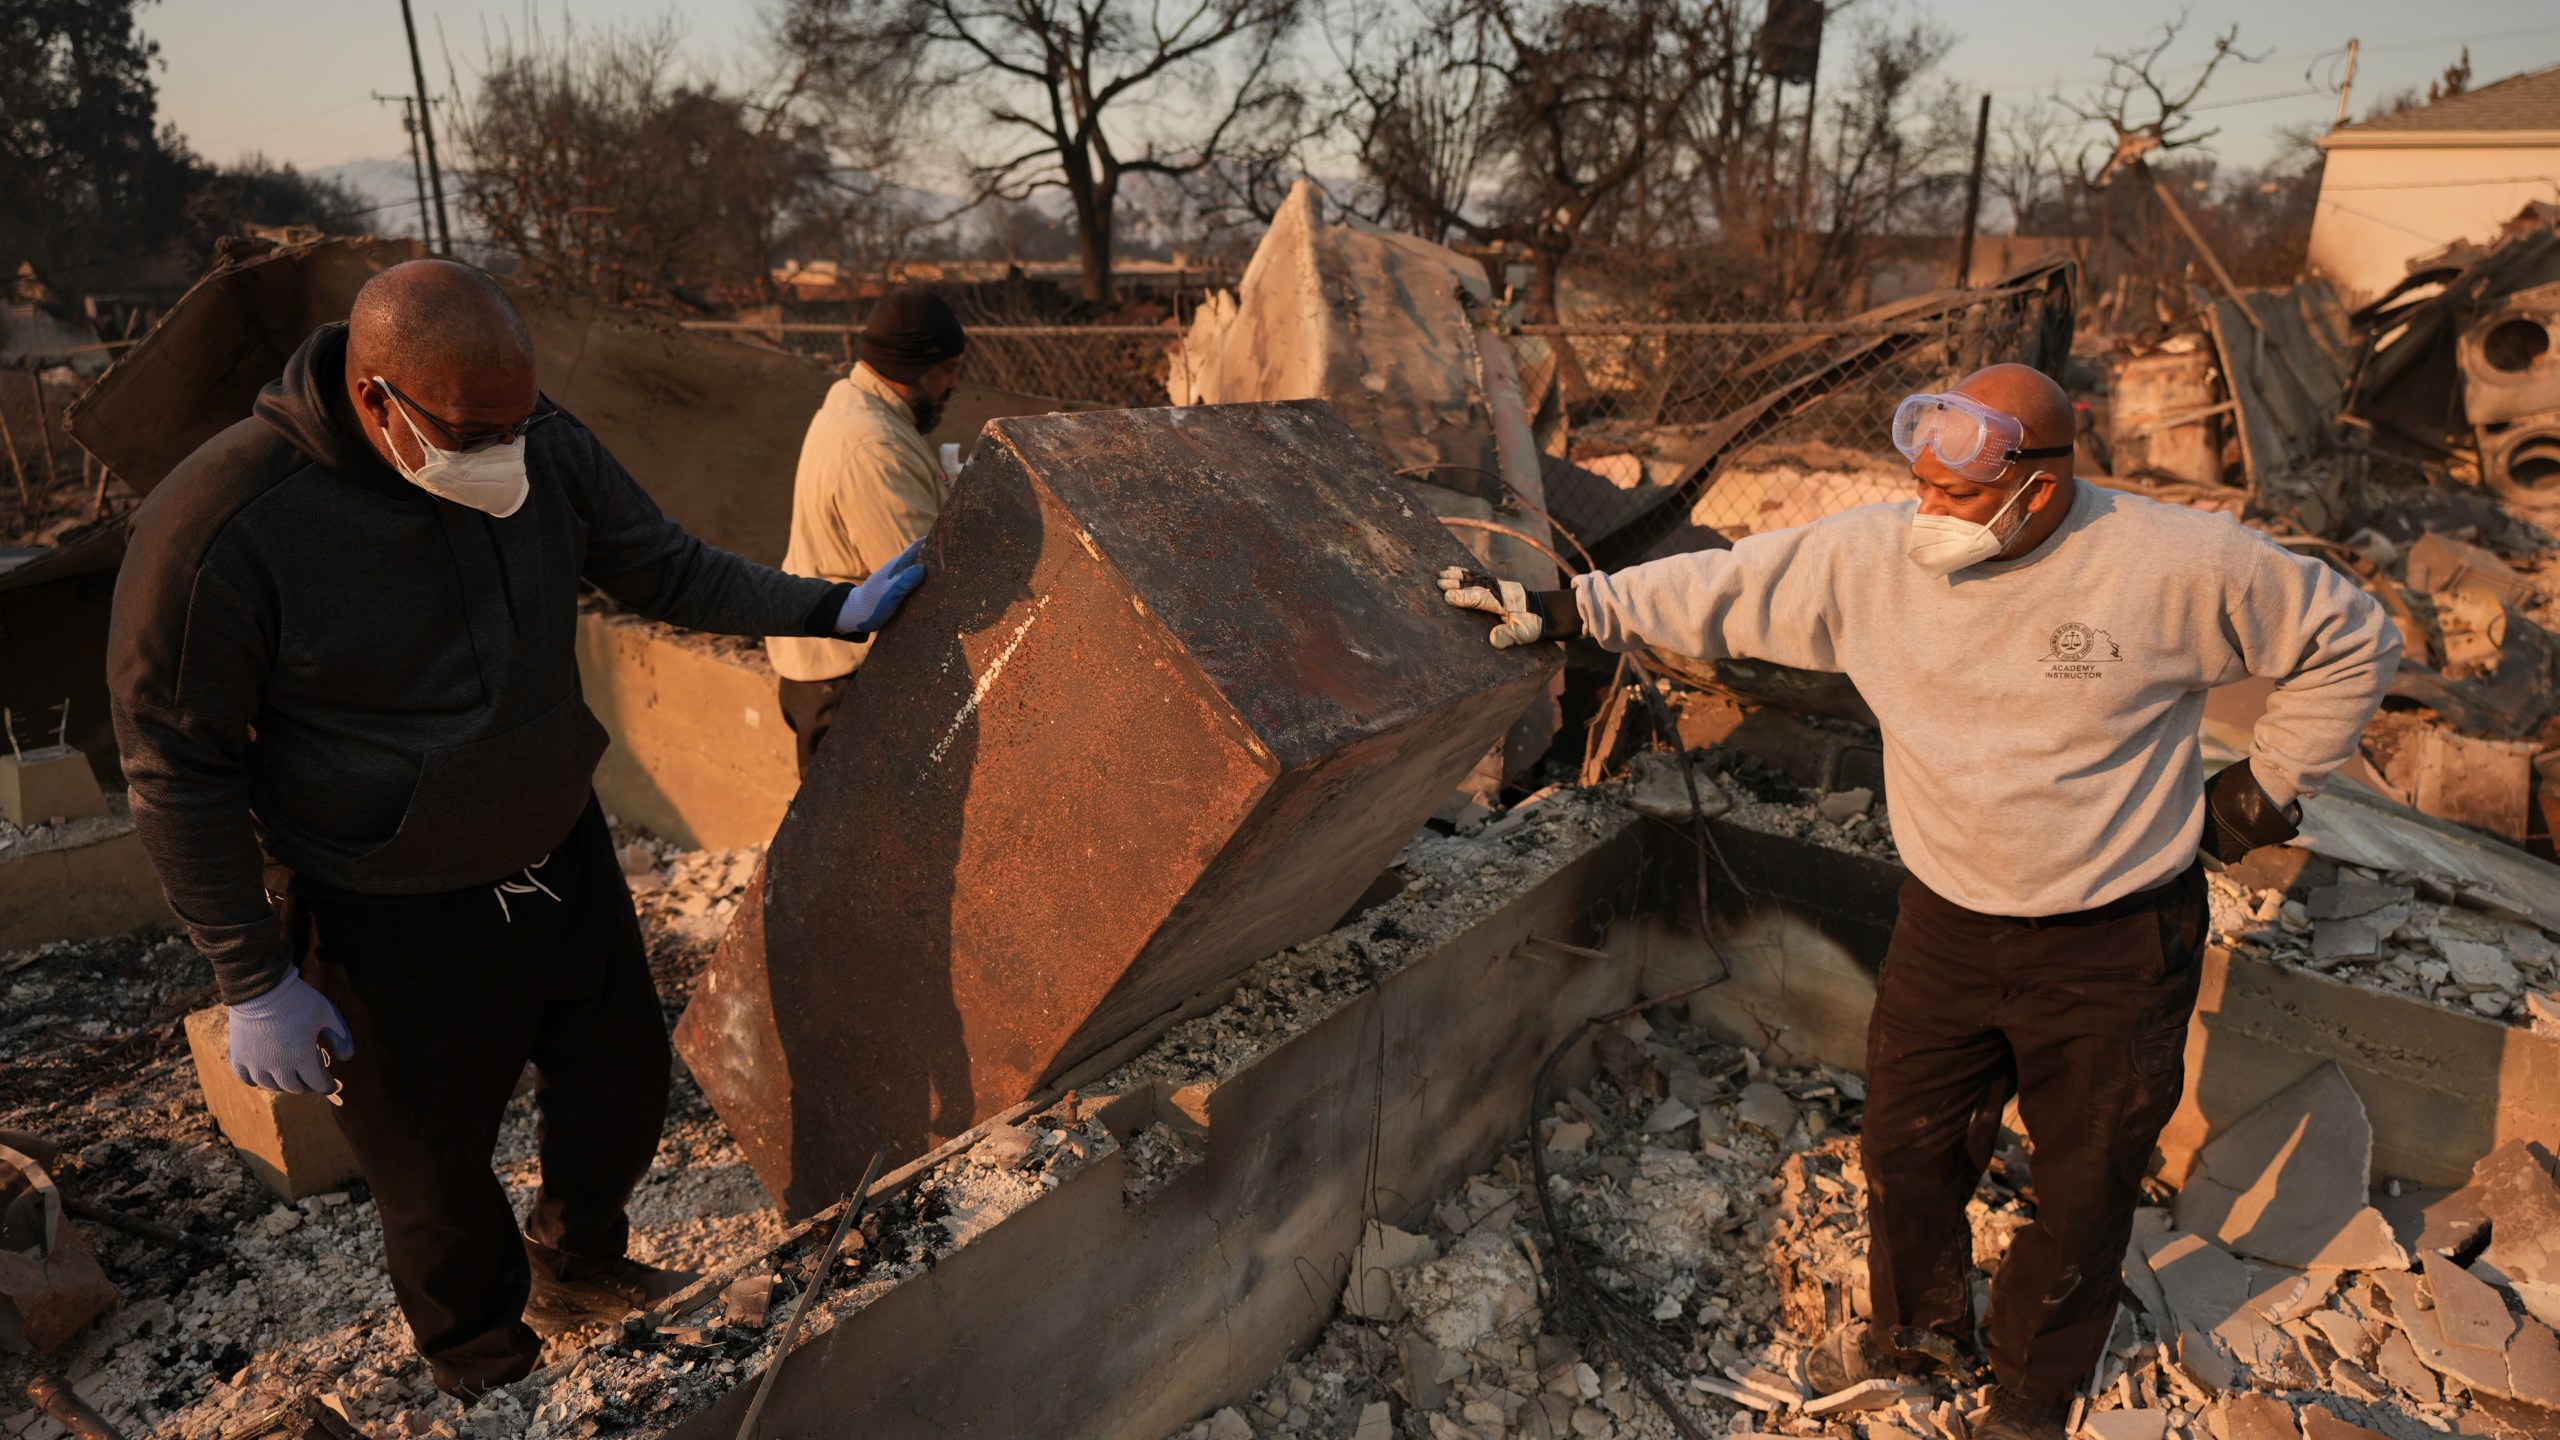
676, 402, 1559, 1212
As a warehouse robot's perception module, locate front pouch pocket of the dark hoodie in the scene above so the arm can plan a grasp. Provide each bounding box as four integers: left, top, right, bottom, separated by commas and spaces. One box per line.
340, 689, 609, 894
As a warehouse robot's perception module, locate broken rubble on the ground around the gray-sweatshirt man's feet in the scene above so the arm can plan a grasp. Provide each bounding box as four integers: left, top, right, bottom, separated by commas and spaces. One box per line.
1170, 1012, 2560, 1440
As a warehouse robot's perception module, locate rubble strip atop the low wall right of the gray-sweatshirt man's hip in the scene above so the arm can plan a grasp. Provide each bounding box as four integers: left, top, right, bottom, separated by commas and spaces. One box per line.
2207, 866, 2560, 1033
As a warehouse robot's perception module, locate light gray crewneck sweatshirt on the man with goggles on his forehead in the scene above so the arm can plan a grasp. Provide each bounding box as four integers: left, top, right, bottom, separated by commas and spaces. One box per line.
1574, 482, 2401, 915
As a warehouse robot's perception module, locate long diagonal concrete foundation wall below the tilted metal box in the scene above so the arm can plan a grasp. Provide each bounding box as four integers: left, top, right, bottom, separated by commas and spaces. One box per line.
668, 828, 1641, 1440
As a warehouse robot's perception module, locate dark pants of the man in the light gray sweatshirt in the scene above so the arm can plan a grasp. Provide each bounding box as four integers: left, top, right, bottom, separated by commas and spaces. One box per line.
1864, 866, 2207, 1402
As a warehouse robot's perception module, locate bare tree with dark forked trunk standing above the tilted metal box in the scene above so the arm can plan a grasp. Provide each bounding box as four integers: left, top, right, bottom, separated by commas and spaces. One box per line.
904, 0, 1303, 305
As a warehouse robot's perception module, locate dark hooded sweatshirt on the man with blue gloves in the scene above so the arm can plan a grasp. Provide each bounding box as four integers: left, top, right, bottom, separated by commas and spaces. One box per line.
108, 325, 845, 1002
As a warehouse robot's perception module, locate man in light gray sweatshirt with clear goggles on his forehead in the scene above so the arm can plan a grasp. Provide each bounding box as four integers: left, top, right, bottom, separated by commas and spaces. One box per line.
1441, 366, 2399, 1440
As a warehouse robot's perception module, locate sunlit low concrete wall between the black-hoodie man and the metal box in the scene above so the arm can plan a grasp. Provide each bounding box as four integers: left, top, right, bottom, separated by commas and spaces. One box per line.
579, 610, 799, 851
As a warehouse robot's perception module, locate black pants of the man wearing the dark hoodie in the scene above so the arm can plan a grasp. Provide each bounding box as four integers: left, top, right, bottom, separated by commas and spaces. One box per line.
284, 799, 668, 1391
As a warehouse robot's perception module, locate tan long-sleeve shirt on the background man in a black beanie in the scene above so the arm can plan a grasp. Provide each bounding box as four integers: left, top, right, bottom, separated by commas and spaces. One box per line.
765, 364, 950, 679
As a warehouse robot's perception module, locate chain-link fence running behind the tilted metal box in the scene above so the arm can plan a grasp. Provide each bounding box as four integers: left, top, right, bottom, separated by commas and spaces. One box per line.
691, 284, 2071, 564
